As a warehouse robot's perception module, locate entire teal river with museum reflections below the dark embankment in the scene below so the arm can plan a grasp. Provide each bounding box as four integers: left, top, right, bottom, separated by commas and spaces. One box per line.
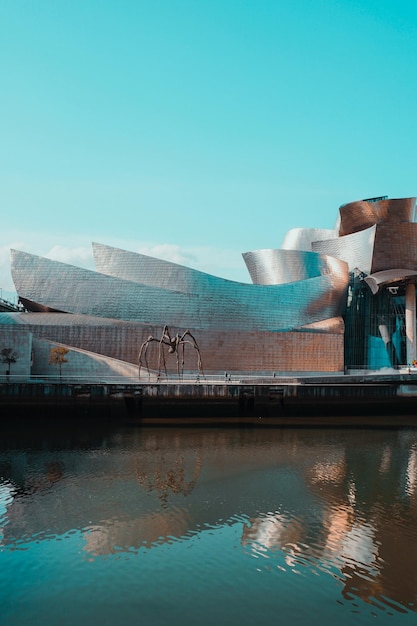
0, 425, 417, 626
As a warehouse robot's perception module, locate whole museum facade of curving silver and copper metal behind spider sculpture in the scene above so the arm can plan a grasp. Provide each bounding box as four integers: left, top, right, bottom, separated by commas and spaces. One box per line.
4, 193, 417, 373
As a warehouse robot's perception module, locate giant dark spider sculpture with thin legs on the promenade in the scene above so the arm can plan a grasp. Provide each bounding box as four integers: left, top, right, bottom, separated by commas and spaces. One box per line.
138, 326, 204, 380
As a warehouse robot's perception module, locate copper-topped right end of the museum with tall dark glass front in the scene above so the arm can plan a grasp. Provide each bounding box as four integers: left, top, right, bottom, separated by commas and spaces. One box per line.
334, 197, 417, 369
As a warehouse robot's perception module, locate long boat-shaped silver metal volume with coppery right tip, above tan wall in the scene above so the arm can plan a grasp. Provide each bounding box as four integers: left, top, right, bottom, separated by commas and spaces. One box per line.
12, 250, 348, 334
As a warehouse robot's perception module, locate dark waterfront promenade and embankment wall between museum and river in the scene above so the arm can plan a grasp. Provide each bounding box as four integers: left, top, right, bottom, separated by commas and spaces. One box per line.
0, 369, 417, 426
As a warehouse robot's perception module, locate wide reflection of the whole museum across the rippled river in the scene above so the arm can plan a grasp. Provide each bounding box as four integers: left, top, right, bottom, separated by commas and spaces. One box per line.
0, 422, 417, 614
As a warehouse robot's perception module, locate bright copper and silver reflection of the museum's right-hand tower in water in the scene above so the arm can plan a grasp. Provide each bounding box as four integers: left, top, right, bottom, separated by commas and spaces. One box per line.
242, 428, 417, 611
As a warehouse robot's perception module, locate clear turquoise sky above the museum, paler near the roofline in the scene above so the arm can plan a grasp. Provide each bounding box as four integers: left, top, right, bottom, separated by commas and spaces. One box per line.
0, 0, 417, 291
